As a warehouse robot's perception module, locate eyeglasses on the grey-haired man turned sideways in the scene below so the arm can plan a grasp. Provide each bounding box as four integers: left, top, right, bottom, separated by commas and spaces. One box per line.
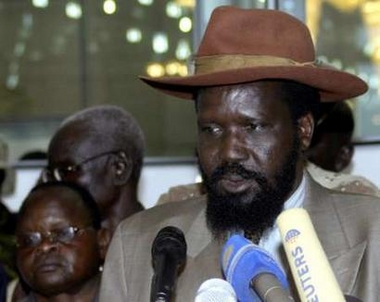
41, 151, 121, 182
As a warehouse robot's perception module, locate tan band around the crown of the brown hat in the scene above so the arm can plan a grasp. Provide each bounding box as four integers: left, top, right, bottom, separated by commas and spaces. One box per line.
194, 55, 316, 74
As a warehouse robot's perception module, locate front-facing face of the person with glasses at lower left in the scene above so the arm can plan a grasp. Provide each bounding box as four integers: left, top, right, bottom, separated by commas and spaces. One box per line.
16, 187, 102, 296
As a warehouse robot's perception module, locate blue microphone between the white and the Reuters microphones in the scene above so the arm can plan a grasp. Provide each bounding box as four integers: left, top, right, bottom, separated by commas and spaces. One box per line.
222, 234, 293, 302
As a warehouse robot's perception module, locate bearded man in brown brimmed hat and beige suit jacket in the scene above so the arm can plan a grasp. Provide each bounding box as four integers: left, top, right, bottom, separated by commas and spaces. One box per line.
100, 7, 380, 302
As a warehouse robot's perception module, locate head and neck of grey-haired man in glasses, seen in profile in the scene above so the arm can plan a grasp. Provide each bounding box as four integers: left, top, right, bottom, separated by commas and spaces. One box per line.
42, 105, 145, 233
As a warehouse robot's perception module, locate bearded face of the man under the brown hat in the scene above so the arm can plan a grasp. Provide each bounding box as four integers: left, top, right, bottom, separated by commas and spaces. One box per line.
197, 82, 301, 236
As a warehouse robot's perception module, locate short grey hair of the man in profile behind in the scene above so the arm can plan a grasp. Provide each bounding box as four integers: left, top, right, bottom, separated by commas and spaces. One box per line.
60, 105, 145, 180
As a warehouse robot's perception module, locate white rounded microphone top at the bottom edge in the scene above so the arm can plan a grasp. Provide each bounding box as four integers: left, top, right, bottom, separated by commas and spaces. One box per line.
194, 278, 237, 302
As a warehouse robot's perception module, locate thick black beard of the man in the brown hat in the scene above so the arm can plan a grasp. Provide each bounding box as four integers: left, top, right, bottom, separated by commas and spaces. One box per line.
200, 135, 300, 238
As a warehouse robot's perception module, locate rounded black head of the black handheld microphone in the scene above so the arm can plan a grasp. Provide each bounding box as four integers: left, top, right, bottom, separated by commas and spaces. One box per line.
152, 226, 187, 266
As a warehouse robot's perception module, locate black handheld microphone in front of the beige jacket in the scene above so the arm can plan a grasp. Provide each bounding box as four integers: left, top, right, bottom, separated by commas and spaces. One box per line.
150, 226, 187, 302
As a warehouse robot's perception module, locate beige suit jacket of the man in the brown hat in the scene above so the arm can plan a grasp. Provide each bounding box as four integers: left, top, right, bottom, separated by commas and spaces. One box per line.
100, 176, 380, 302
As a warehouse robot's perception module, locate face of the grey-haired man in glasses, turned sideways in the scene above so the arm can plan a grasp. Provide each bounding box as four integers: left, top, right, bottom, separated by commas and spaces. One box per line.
48, 123, 115, 214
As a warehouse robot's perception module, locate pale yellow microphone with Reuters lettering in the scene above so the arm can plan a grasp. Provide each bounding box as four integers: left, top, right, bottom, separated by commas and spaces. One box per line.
277, 208, 352, 302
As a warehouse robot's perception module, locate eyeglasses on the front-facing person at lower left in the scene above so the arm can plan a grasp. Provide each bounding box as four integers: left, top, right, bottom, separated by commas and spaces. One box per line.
16, 226, 93, 248
